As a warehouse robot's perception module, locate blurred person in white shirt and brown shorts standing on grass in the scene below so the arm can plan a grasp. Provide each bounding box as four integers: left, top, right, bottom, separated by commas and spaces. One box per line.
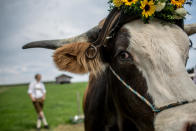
28, 74, 49, 131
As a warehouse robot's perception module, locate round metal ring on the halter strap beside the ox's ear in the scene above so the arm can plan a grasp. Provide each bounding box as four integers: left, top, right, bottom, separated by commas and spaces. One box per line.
85, 44, 98, 60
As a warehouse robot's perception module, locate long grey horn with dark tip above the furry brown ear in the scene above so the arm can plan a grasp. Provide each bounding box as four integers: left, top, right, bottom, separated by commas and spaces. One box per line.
22, 26, 100, 50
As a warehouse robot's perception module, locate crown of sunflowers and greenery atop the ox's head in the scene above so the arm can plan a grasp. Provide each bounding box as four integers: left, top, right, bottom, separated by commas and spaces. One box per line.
109, 0, 192, 23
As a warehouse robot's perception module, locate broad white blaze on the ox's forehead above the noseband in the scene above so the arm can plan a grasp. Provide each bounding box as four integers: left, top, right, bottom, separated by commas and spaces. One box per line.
124, 20, 196, 107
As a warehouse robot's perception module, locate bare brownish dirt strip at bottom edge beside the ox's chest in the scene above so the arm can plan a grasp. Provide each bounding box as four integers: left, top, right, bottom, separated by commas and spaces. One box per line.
54, 124, 84, 131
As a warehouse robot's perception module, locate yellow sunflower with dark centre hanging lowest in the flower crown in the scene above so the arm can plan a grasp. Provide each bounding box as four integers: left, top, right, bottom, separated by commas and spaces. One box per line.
140, 0, 156, 18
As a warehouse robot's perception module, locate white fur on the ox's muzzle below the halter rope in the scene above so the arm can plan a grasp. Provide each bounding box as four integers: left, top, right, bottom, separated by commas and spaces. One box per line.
154, 103, 196, 131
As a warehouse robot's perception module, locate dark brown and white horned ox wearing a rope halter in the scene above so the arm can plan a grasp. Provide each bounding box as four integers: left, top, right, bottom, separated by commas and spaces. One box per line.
23, 7, 196, 131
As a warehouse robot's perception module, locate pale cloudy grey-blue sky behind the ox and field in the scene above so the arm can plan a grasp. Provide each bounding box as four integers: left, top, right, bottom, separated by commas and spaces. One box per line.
0, 0, 196, 84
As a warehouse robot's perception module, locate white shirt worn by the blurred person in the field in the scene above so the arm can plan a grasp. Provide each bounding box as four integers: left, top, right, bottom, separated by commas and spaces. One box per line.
28, 81, 46, 99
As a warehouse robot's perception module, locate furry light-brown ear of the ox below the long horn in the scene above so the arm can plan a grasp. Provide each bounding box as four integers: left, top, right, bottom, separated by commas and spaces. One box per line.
53, 42, 102, 74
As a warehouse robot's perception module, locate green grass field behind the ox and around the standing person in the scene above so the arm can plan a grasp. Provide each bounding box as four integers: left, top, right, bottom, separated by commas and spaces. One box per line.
0, 83, 87, 131
